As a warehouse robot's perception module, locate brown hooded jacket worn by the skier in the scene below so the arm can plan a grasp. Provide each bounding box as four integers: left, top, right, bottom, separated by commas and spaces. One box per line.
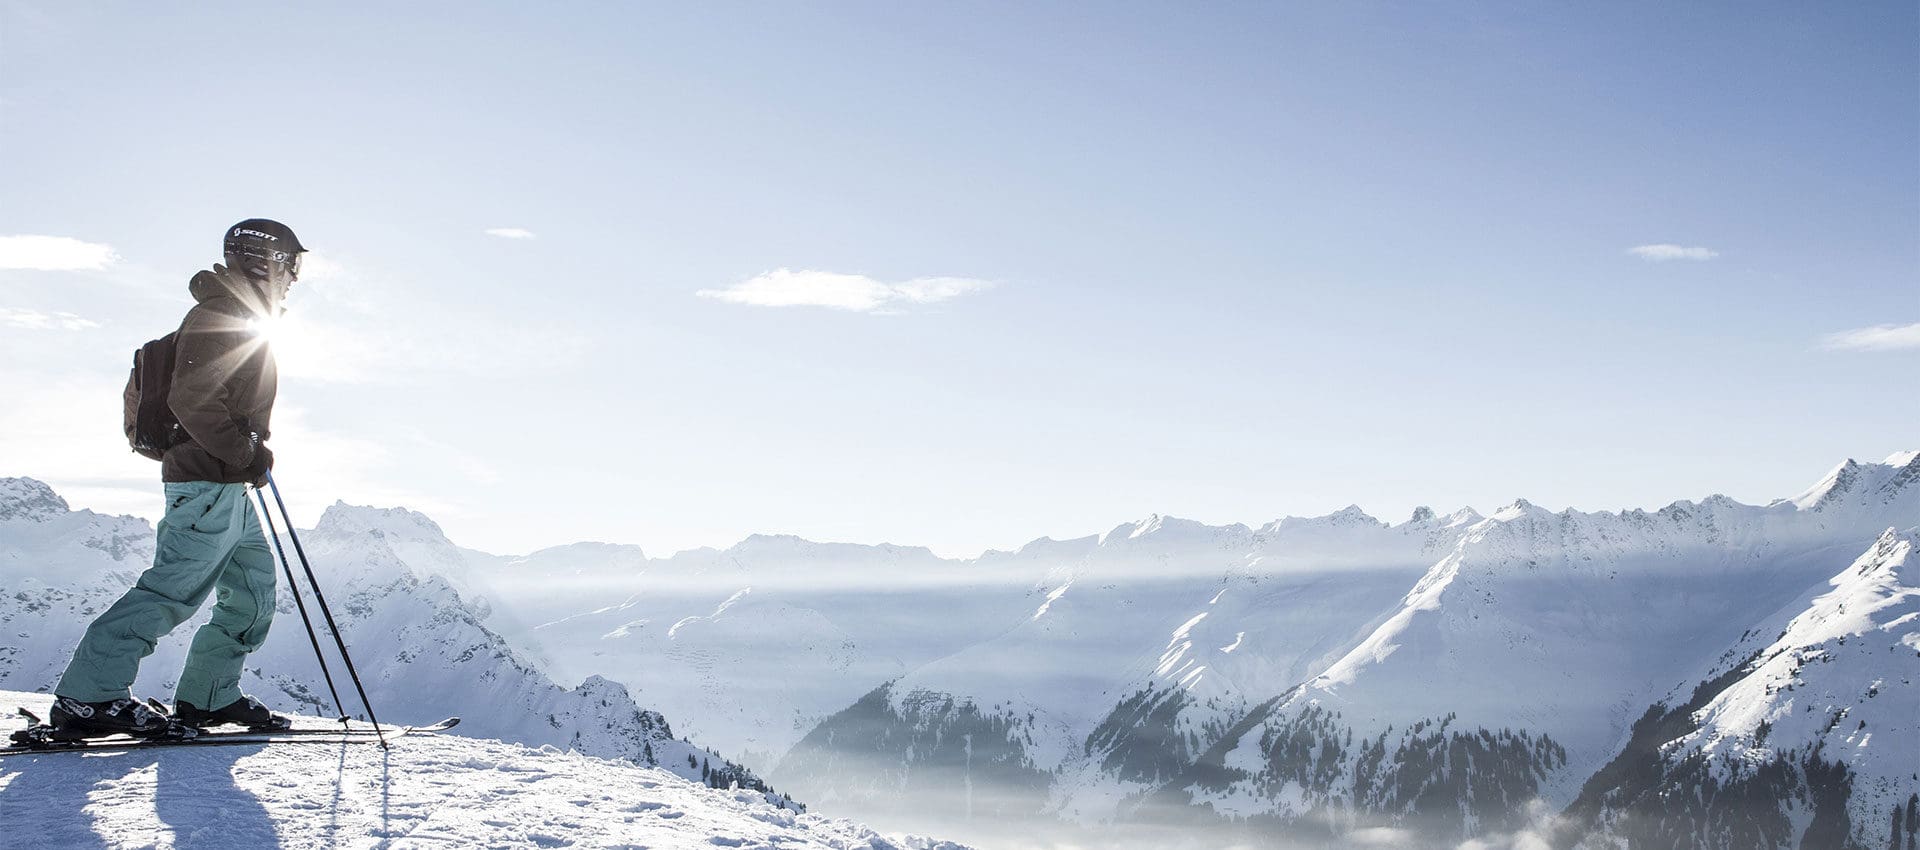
159, 265, 280, 484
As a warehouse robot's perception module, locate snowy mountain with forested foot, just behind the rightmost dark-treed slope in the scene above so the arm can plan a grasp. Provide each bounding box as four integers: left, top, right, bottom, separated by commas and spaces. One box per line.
1175, 462, 1920, 840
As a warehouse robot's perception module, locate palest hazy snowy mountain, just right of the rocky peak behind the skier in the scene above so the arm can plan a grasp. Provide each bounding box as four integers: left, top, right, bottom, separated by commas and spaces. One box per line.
482, 535, 1031, 769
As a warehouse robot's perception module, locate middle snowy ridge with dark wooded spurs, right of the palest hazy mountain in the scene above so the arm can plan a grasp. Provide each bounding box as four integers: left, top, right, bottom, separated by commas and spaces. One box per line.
774, 508, 1478, 836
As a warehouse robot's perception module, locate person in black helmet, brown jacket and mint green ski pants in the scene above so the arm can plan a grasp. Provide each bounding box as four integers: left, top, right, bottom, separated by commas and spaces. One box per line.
50, 219, 305, 737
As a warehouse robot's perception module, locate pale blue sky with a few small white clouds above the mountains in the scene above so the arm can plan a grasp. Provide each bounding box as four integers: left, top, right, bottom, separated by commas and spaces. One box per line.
0, 2, 1920, 555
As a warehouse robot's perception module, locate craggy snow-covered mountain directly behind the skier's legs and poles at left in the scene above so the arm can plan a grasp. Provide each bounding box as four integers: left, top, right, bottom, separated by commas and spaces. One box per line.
0, 478, 779, 802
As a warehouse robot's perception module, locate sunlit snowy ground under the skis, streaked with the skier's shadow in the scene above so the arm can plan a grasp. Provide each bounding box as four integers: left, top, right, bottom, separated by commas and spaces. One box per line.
0, 691, 962, 850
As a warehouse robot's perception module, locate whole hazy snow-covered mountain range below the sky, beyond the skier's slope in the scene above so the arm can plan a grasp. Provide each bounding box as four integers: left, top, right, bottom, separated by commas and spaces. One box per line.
0, 453, 1920, 848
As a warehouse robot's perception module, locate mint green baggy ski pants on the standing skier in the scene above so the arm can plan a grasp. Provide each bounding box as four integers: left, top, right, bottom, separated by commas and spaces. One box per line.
54, 482, 275, 710
